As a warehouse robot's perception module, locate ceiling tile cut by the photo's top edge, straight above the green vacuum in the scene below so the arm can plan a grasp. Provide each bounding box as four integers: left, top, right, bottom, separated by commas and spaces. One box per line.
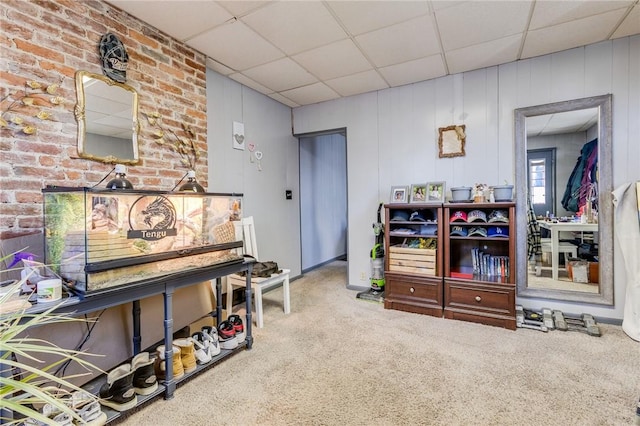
327, 1, 429, 35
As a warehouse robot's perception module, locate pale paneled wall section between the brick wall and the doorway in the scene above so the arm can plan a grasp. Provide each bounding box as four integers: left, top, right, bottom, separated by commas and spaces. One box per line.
207, 70, 300, 277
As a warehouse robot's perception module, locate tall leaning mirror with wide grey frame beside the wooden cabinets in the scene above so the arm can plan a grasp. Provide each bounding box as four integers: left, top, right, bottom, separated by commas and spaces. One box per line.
515, 95, 613, 305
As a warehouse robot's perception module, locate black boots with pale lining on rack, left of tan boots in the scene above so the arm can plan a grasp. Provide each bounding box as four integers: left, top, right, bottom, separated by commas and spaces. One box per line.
98, 352, 158, 411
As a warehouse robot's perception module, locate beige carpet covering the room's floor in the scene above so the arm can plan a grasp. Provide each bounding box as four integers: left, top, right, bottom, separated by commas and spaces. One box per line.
116, 262, 640, 426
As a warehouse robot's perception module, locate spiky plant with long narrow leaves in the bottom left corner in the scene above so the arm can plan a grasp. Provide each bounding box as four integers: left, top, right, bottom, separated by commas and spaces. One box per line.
0, 251, 106, 425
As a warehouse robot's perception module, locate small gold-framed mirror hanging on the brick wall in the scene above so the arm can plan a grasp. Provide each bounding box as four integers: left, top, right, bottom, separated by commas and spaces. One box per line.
75, 71, 139, 164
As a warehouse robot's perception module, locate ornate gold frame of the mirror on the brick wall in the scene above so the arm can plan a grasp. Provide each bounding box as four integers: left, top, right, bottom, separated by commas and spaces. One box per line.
74, 71, 140, 164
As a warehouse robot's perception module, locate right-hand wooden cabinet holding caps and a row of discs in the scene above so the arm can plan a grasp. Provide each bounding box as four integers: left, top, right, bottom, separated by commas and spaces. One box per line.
442, 203, 516, 330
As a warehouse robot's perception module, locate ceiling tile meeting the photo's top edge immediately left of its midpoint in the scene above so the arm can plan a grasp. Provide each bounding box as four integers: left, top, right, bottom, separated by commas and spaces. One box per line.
242, 1, 347, 55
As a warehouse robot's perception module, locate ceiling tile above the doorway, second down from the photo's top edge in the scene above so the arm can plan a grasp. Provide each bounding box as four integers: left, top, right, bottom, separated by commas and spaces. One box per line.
292, 39, 373, 80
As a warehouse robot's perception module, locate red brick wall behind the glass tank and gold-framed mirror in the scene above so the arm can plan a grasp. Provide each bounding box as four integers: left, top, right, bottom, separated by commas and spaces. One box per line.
0, 0, 207, 240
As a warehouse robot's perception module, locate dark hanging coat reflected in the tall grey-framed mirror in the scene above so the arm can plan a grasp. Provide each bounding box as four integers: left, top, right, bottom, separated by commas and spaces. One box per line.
562, 138, 598, 212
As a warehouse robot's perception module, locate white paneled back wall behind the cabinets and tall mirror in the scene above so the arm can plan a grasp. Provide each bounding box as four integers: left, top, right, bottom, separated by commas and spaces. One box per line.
293, 36, 640, 319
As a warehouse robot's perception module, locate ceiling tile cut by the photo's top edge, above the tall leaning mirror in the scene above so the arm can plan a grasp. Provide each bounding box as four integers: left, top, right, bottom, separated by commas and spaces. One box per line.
529, 0, 633, 30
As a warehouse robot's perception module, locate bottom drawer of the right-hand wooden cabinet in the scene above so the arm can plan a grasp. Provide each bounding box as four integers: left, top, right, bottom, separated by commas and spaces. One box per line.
444, 280, 515, 316
